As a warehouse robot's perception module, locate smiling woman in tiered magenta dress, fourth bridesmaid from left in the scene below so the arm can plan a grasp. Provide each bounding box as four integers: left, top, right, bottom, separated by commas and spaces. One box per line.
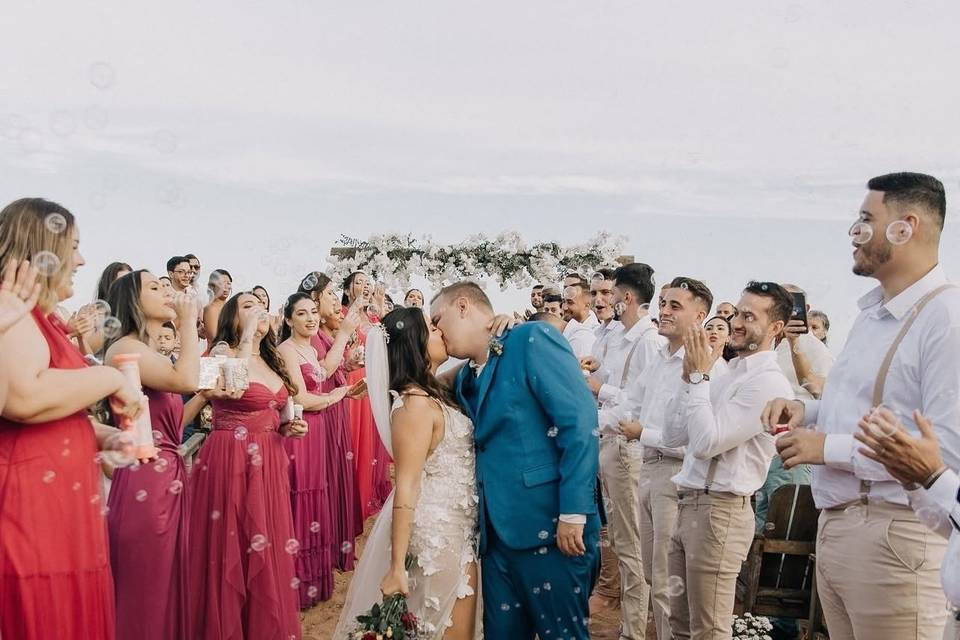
279, 293, 360, 609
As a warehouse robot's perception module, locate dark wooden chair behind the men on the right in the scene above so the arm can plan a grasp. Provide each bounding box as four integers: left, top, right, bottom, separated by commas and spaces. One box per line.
737, 484, 818, 620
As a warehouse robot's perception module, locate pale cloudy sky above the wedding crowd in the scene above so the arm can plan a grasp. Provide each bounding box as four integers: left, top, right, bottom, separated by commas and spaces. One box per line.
0, 0, 960, 349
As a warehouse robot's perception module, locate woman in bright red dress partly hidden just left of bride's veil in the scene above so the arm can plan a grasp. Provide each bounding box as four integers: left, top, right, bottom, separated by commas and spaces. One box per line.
341, 271, 393, 520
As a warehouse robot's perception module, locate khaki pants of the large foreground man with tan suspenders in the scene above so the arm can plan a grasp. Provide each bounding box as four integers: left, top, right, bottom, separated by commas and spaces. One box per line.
817, 503, 947, 640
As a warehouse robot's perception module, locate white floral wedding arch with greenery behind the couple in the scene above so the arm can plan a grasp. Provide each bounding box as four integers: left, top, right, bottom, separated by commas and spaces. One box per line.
329, 232, 632, 290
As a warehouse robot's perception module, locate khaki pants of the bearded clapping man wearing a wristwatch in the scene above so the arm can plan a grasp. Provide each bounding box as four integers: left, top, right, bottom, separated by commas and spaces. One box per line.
667, 489, 756, 640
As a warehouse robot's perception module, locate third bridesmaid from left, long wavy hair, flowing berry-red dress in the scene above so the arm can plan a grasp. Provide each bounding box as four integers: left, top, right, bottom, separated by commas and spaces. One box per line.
186, 293, 306, 640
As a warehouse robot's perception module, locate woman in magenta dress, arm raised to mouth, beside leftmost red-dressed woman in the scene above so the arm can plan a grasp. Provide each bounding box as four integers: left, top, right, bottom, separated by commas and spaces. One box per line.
105, 270, 200, 640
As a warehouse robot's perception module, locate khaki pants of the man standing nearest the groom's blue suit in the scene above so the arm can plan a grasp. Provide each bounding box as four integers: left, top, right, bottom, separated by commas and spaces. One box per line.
600, 436, 650, 640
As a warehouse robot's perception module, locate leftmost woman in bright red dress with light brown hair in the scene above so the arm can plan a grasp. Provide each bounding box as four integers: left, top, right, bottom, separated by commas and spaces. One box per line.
0, 198, 140, 640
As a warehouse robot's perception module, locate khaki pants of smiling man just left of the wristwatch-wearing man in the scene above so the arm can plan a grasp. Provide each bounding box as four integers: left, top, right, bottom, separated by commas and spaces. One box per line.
640, 456, 683, 640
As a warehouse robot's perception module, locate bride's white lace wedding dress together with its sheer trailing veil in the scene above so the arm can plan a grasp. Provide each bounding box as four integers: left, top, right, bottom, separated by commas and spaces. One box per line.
333, 394, 483, 640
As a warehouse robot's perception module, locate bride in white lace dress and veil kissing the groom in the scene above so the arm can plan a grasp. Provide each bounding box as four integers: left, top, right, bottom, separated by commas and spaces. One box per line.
334, 308, 483, 640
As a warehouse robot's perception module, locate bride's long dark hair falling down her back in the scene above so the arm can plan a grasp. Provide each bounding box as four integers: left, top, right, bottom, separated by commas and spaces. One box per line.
381, 307, 458, 408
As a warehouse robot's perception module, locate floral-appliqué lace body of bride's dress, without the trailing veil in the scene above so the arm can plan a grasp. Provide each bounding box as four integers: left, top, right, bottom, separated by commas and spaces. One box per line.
392, 394, 480, 638
